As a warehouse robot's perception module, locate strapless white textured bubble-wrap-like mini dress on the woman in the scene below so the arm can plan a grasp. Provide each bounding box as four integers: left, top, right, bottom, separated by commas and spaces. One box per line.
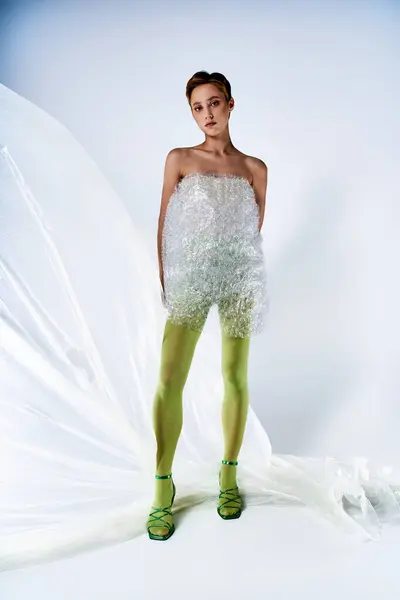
162, 173, 268, 337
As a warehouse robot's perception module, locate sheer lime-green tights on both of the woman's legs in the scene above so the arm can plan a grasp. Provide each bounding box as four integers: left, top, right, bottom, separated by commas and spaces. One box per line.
147, 319, 250, 535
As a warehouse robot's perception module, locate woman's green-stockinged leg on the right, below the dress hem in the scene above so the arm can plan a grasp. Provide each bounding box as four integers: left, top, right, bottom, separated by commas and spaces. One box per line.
219, 333, 250, 515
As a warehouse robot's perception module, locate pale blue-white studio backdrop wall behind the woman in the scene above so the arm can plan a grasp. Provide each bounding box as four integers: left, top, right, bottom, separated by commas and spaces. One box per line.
0, 0, 400, 456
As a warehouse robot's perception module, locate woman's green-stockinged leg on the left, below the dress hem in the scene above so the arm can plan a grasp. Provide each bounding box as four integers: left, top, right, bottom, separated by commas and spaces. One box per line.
147, 320, 201, 535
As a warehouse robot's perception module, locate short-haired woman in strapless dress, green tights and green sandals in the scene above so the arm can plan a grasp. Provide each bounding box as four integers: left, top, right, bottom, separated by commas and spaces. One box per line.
147, 71, 268, 540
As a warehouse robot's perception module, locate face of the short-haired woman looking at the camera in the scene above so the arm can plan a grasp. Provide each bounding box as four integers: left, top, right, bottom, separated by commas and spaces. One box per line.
190, 83, 234, 135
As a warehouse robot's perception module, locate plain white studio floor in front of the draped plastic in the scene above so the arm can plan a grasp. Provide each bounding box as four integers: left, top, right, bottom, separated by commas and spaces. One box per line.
0, 504, 400, 600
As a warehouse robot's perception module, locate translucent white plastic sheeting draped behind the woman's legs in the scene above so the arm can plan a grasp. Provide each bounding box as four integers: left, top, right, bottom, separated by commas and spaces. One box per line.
0, 86, 400, 569
